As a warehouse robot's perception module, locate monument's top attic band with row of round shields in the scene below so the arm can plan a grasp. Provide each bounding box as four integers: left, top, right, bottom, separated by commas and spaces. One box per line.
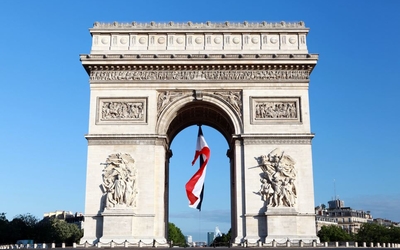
90, 22, 308, 54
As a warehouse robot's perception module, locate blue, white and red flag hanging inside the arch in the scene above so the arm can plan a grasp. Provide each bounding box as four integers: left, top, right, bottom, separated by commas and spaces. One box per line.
185, 126, 210, 211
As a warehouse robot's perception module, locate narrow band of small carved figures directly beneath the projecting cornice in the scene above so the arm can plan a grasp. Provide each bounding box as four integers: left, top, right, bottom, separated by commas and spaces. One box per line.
90, 69, 310, 82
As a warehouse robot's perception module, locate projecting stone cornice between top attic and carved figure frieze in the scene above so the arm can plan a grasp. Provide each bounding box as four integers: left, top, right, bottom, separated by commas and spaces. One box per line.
80, 54, 318, 74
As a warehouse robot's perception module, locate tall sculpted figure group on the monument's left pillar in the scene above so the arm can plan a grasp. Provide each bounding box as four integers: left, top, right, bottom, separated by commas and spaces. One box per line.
101, 153, 138, 209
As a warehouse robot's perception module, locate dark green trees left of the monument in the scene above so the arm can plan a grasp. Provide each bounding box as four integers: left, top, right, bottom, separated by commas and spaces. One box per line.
0, 213, 83, 246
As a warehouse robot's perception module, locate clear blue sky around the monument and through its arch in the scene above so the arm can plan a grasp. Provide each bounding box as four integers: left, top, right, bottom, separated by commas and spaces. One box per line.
0, 0, 400, 240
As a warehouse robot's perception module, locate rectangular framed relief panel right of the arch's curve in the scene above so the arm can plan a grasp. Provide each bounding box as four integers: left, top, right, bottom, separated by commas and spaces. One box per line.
251, 97, 301, 123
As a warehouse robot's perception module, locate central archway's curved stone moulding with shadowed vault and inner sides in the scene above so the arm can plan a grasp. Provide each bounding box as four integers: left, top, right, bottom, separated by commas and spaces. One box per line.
157, 91, 242, 242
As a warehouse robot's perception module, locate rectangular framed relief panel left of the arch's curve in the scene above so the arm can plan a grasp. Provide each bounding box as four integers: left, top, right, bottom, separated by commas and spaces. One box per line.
97, 98, 147, 123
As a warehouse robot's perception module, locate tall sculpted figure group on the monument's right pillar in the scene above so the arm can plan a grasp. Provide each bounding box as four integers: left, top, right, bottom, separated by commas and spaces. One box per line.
257, 148, 297, 207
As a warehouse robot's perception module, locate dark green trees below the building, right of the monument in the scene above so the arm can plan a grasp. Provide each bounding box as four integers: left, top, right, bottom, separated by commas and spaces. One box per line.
317, 223, 400, 244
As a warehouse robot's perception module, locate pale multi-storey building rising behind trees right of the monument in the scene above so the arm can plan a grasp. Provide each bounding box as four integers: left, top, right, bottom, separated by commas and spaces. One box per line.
315, 199, 373, 233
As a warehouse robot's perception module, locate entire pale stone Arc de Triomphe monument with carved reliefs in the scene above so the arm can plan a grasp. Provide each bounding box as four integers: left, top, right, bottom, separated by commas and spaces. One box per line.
80, 22, 318, 244
